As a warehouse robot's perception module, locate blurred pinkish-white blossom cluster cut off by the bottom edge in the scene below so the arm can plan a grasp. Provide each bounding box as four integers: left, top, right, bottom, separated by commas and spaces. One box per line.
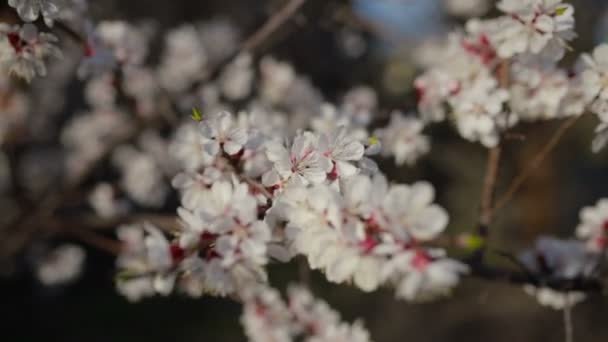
241, 286, 370, 342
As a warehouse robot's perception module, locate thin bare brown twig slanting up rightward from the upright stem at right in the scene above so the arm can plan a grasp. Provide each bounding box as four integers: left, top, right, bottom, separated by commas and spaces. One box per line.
492, 115, 580, 212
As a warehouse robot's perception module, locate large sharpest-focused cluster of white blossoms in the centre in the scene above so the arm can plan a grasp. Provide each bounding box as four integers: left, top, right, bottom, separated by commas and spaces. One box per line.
115, 107, 460, 300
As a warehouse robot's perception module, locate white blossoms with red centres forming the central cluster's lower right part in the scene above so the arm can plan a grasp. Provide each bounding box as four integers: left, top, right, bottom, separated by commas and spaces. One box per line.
271, 175, 467, 300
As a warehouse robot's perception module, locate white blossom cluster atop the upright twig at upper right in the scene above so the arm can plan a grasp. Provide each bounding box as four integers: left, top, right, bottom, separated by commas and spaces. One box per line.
415, 0, 589, 147
